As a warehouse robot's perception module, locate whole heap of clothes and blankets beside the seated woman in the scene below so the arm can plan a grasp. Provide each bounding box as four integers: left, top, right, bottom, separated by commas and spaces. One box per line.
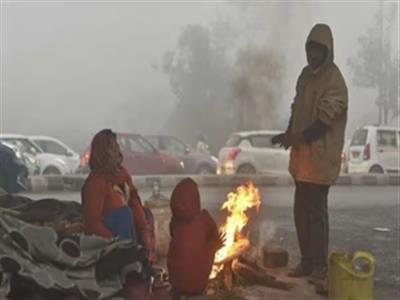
0, 194, 168, 300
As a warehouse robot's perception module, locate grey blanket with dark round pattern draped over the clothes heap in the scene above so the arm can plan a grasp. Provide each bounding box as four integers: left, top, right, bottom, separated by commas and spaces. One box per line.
0, 212, 150, 299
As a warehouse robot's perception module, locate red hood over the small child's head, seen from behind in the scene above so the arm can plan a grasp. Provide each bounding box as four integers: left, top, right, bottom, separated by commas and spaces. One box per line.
171, 178, 200, 220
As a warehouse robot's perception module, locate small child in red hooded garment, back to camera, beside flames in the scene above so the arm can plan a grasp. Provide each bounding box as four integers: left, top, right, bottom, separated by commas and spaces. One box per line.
167, 178, 219, 296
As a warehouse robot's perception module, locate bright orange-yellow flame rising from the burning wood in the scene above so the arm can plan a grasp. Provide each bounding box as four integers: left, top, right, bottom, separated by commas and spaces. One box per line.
210, 182, 261, 278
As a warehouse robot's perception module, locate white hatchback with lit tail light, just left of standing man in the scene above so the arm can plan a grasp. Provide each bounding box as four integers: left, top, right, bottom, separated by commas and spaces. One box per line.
219, 130, 289, 174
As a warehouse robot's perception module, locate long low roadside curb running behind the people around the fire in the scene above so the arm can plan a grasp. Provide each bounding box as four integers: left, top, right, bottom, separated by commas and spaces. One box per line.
29, 174, 400, 193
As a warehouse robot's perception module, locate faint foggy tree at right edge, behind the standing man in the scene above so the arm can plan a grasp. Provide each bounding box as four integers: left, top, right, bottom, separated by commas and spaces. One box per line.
348, 6, 400, 124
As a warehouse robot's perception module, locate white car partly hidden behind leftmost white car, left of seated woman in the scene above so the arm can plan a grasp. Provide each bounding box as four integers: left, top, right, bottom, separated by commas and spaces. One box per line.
29, 136, 80, 173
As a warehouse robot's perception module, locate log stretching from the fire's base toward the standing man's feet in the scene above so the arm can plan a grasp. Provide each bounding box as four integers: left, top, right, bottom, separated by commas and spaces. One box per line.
233, 261, 294, 291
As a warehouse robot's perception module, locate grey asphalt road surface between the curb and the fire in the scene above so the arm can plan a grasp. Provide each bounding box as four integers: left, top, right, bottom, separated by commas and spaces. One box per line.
21, 186, 400, 300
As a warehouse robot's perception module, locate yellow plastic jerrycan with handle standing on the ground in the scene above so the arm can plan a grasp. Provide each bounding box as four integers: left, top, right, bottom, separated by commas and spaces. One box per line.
329, 251, 375, 300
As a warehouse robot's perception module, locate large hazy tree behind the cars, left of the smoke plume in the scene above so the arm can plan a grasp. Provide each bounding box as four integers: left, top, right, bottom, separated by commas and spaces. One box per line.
163, 23, 232, 149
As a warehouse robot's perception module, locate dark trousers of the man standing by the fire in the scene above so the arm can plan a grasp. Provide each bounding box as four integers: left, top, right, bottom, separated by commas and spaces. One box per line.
294, 181, 330, 269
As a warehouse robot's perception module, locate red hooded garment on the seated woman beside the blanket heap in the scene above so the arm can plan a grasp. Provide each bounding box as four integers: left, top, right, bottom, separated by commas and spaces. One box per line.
81, 130, 148, 246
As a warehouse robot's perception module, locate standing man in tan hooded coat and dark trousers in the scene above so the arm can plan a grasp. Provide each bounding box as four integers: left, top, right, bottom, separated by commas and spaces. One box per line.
272, 24, 348, 284
